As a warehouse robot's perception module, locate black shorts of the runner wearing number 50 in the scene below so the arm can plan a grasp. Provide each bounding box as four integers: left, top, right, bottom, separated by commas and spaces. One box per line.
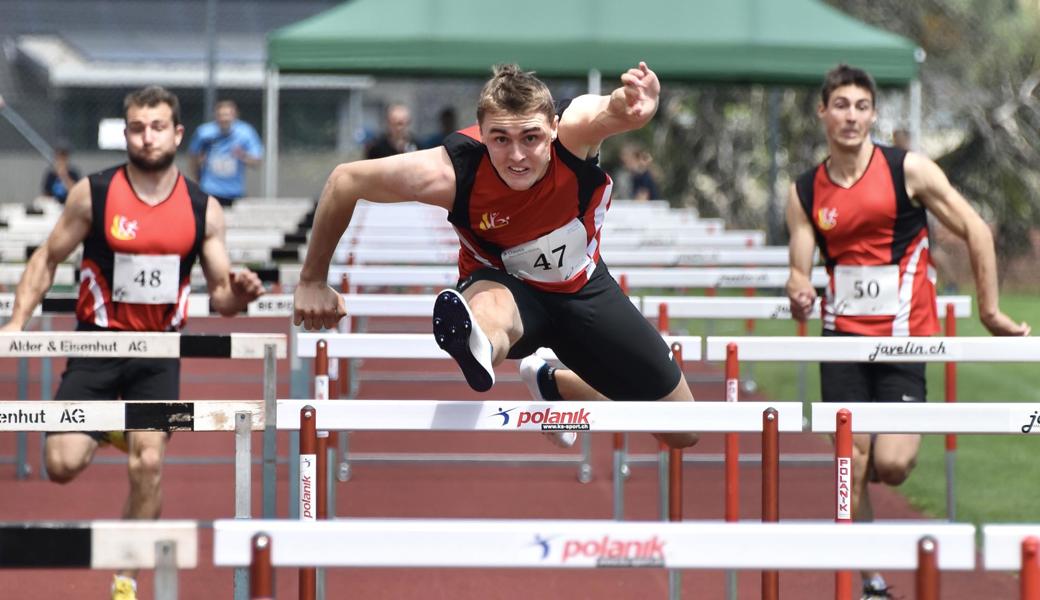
820, 330, 928, 402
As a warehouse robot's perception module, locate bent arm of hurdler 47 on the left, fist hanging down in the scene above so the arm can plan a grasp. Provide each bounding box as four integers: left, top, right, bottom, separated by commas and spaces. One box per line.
292, 148, 456, 330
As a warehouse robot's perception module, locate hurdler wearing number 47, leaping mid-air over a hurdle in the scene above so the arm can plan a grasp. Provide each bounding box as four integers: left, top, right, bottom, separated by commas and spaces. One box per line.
293, 62, 697, 447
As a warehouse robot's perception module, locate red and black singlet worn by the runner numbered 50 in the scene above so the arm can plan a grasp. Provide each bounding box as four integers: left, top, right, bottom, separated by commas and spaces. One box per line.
796, 146, 939, 336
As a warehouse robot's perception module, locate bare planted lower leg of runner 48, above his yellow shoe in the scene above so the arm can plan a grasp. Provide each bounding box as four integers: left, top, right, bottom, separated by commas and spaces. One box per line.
120, 432, 167, 578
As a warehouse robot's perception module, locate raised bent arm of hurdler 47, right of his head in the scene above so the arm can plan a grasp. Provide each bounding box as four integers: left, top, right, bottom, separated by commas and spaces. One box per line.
560, 62, 660, 158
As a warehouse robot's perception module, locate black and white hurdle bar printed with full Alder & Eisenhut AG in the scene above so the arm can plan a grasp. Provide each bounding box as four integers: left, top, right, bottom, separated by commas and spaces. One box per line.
0, 332, 286, 359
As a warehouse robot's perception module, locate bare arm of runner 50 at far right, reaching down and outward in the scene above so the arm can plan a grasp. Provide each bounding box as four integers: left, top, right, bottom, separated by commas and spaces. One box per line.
903, 152, 1030, 336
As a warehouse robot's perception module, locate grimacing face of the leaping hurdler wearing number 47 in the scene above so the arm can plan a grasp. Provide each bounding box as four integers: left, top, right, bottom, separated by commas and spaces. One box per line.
480, 112, 557, 190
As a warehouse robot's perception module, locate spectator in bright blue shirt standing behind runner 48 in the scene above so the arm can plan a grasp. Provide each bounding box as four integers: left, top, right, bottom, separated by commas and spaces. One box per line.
188, 100, 263, 206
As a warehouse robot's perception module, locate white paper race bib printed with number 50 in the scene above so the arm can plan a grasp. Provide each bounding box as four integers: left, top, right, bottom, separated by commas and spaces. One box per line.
833, 264, 900, 316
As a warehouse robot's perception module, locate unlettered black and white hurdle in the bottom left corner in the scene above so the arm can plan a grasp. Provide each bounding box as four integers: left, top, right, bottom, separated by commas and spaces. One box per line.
0, 520, 199, 600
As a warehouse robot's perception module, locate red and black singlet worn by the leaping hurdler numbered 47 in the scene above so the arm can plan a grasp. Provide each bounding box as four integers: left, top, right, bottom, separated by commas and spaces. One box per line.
444, 106, 613, 293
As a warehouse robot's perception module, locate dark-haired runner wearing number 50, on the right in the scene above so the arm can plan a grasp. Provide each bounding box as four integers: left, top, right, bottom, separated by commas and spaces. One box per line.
787, 64, 1030, 599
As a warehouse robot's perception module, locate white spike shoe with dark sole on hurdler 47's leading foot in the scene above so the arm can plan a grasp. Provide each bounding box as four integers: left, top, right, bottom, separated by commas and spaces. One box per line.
434, 289, 495, 392
